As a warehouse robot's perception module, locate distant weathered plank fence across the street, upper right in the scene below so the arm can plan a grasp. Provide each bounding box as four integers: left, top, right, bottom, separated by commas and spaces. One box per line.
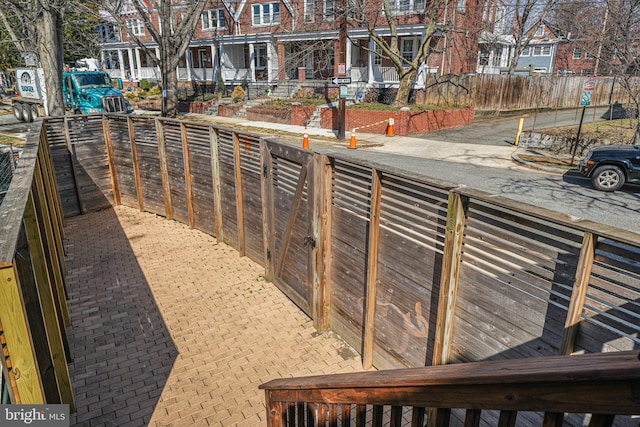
424, 74, 640, 113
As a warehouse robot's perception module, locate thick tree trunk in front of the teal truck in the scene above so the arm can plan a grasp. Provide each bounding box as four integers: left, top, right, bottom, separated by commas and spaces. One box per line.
38, 7, 65, 116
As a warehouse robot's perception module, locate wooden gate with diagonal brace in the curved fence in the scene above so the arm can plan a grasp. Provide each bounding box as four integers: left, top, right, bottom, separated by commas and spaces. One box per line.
262, 141, 322, 319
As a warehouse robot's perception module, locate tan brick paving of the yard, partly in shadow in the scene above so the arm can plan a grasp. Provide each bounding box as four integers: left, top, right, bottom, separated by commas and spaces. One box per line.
65, 207, 362, 427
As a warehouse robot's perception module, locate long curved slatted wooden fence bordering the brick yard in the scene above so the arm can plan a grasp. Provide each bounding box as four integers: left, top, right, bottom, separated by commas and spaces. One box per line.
46, 116, 640, 382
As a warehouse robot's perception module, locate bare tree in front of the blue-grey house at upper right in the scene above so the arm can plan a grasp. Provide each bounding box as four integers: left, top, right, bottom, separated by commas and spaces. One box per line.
509, 0, 556, 74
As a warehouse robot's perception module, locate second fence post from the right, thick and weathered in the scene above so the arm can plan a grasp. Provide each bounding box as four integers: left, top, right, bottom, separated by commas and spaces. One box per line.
433, 191, 468, 365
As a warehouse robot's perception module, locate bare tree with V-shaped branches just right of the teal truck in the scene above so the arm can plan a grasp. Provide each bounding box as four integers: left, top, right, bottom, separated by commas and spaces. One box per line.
104, 0, 207, 117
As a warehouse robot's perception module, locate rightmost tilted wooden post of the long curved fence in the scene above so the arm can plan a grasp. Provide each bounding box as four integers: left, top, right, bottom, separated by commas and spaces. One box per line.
560, 232, 597, 355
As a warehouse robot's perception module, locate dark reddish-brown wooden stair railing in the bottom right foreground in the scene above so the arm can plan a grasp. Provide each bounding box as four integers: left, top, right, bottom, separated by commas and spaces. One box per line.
260, 350, 640, 427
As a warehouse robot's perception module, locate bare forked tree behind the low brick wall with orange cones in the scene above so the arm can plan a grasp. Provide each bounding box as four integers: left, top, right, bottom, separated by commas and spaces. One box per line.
342, 0, 442, 107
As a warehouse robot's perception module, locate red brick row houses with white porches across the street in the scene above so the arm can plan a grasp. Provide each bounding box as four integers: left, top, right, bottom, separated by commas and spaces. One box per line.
100, 0, 490, 87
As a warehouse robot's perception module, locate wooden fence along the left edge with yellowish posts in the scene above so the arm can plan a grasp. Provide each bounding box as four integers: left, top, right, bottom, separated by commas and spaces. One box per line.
0, 124, 74, 411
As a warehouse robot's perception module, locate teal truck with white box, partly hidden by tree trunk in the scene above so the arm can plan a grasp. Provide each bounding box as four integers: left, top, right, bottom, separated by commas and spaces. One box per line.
11, 67, 133, 122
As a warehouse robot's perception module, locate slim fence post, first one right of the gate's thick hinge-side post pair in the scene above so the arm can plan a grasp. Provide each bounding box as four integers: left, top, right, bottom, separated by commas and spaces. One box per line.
362, 169, 382, 369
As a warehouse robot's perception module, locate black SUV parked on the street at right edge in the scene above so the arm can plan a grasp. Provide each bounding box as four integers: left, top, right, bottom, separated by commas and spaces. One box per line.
580, 145, 640, 191
